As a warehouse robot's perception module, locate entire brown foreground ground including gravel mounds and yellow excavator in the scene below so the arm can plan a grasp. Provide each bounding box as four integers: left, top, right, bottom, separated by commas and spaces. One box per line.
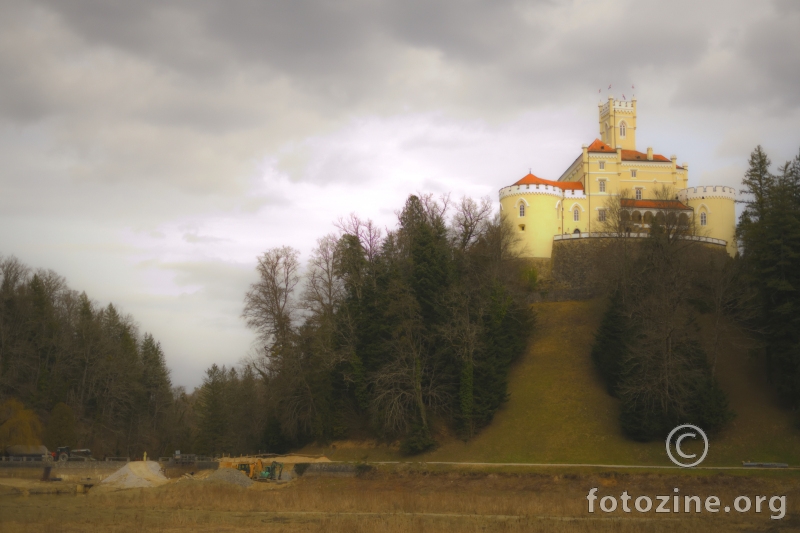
0, 455, 800, 533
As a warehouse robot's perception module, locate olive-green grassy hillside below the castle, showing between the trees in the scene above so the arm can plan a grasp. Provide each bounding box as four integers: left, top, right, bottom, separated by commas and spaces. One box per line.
309, 300, 800, 466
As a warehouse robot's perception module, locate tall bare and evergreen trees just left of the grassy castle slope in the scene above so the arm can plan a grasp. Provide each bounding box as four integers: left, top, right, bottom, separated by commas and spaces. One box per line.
228, 196, 533, 454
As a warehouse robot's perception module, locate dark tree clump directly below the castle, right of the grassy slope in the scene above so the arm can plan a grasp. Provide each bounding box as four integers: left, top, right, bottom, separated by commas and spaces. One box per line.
592, 189, 731, 441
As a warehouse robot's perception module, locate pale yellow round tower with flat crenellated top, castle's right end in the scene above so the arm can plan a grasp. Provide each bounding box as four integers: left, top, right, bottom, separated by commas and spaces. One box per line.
678, 185, 736, 256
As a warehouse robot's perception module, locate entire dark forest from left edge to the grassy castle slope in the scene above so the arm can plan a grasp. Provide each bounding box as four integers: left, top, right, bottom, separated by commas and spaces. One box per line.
0, 195, 536, 456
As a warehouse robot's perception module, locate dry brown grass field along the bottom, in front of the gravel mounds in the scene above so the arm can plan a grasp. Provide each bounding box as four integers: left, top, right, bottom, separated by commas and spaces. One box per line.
0, 466, 800, 533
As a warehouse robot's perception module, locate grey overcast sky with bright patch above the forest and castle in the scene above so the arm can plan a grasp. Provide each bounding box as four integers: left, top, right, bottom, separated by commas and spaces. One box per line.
0, 0, 800, 388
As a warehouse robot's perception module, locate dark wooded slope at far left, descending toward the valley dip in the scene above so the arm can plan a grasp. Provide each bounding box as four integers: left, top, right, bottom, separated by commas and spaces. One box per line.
0, 257, 176, 456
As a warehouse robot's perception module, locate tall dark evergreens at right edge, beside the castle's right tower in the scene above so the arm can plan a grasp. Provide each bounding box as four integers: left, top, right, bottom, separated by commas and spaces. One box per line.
737, 146, 800, 416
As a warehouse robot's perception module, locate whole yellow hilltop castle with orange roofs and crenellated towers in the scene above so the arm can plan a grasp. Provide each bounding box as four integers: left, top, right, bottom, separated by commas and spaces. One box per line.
500, 97, 736, 258
